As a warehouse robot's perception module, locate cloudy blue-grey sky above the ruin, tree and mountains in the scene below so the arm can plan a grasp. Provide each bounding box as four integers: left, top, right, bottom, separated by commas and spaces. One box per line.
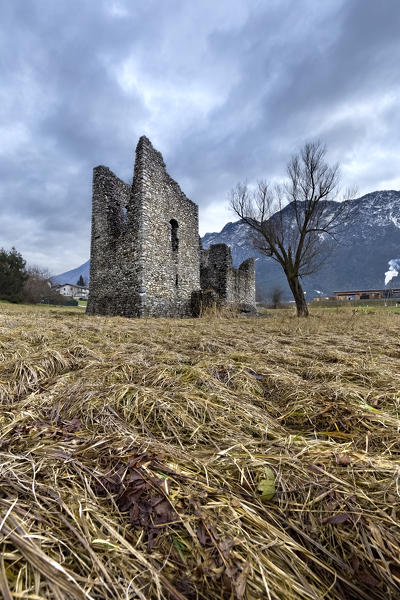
0, 0, 400, 273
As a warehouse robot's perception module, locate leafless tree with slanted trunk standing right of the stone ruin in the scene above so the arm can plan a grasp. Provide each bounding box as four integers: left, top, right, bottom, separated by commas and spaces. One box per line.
230, 142, 351, 317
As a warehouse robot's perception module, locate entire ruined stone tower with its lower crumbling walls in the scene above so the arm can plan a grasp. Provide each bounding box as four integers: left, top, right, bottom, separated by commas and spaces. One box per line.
87, 136, 255, 317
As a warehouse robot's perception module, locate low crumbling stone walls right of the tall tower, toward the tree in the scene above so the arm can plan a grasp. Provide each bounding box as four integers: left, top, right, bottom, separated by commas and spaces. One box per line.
200, 244, 256, 312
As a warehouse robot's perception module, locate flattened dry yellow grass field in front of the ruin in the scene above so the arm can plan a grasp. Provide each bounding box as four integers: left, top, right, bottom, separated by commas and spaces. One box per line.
0, 304, 400, 600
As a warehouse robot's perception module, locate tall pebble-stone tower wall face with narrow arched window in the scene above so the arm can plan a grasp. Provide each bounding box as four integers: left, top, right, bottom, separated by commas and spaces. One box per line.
138, 138, 200, 317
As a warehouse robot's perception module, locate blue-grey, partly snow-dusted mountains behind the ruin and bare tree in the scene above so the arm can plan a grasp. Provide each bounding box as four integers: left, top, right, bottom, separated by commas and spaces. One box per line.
52, 190, 400, 298
